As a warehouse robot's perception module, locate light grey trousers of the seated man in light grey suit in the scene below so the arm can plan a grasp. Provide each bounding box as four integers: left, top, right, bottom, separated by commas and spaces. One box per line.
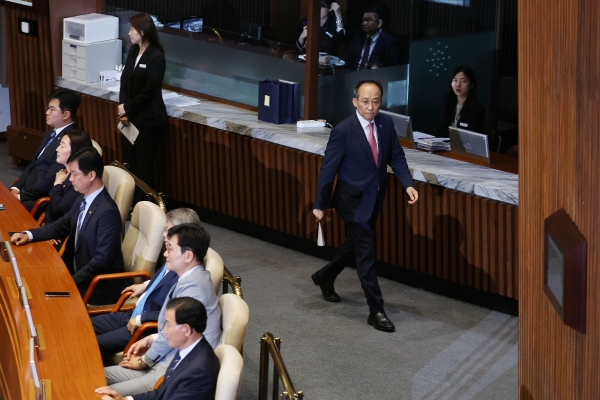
104, 360, 169, 397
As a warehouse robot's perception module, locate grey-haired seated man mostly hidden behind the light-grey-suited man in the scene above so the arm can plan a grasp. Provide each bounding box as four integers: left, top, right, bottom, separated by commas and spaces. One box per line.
92, 208, 200, 355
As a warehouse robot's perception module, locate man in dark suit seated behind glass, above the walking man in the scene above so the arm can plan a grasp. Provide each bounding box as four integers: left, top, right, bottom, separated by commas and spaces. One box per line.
344, 6, 406, 71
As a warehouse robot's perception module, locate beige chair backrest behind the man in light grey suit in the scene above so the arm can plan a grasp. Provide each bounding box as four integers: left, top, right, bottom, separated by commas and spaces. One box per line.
219, 293, 250, 353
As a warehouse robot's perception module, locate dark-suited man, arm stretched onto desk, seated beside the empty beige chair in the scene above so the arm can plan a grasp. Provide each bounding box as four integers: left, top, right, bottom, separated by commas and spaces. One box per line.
11, 147, 123, 304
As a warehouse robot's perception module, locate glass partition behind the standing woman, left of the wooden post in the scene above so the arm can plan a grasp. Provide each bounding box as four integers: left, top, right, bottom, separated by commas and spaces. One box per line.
105, 6, 304, 107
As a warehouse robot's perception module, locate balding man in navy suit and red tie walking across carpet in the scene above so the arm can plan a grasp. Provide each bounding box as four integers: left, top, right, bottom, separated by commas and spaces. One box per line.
312, 80, 419, 332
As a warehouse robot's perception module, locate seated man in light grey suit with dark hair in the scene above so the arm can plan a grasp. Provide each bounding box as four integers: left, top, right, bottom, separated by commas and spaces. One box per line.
104, 224, 221, 396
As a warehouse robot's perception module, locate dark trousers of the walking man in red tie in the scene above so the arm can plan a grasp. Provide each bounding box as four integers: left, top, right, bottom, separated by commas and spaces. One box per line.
318, 218, 384, 313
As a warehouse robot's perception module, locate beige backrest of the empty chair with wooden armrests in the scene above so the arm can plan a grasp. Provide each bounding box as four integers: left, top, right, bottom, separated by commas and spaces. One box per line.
121, 201, 167, 275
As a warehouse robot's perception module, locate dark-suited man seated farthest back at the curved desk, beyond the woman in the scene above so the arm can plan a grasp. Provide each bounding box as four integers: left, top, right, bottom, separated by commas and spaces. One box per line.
10, 89, 80, 211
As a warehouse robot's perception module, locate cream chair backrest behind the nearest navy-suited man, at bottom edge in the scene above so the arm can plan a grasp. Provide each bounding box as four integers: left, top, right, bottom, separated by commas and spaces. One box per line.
215, 344, 244, 400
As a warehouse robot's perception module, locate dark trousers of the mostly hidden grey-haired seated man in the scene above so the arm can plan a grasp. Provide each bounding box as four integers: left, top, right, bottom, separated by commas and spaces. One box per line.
92, 311, 131, 355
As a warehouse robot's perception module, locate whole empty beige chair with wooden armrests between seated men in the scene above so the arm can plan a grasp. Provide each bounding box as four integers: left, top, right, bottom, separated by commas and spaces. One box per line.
84, 201, 166, 314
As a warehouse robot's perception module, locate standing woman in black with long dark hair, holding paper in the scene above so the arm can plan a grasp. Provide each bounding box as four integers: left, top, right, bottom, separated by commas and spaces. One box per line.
117, 13, 167, 186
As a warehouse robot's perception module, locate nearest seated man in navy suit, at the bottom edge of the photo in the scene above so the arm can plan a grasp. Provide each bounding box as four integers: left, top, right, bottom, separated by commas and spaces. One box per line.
96, 297, 220, 400
